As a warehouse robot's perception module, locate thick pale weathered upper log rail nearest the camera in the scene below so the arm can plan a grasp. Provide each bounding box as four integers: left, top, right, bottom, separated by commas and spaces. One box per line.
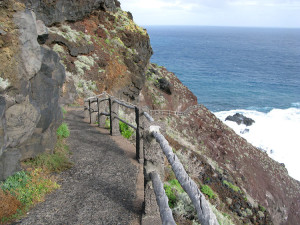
150, 130, 219, 225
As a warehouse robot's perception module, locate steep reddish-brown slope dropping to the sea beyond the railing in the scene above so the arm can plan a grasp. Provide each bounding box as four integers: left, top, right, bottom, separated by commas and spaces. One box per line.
140, 64, 300, 224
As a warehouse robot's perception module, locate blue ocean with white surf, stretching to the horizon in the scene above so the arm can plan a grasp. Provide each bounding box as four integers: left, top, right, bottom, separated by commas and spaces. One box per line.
146, 26, 300, 181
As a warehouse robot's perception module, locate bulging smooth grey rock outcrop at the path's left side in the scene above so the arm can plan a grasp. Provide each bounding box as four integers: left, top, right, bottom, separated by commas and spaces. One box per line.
0, 1, 65, 180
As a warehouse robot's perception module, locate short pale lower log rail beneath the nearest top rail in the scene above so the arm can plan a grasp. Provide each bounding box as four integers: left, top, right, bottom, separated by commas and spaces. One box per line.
150, 172, 176, 225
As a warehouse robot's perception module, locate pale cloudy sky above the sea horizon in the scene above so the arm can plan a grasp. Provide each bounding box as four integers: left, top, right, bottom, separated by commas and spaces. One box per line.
120, 0, 300, 28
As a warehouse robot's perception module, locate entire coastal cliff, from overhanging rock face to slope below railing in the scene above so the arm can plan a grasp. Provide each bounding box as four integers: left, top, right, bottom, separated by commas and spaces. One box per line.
0, 0, 300, 224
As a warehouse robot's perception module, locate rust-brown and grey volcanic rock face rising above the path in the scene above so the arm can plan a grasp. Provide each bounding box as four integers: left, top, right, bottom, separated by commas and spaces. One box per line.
0, 0, 152, 180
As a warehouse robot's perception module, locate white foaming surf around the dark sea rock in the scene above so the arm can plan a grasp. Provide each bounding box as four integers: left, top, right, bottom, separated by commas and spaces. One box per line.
215, 107, 300, 181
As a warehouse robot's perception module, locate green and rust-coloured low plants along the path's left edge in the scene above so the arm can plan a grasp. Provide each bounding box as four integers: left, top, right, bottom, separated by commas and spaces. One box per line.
0, 118, 72, 224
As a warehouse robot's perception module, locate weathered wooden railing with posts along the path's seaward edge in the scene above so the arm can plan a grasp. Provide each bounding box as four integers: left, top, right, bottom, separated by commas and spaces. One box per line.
85, 93, 218, 225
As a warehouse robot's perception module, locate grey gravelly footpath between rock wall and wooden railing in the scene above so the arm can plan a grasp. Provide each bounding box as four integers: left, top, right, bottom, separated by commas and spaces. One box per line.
20, 110, 143, 225
